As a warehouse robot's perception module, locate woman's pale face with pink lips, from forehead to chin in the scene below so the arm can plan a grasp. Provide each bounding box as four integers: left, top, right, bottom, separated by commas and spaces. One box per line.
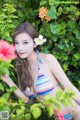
15, 33, 35, 58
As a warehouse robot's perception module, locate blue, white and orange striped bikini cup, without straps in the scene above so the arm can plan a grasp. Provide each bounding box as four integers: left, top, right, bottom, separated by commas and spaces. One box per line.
35, 74, 54, 95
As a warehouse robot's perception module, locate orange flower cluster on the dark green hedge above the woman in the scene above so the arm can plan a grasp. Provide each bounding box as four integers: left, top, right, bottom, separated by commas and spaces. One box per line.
39, 7, 51, 22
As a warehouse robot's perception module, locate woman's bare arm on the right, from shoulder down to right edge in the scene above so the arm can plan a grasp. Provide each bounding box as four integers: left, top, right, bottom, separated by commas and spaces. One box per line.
48, 54, 80, 104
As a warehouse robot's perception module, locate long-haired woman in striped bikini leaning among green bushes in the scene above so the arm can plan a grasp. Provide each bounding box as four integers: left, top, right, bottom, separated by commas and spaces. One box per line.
2, 23, 80, 120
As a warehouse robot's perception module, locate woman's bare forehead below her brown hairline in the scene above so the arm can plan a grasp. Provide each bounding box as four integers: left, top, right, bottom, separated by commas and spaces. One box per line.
15, 32, 32, 41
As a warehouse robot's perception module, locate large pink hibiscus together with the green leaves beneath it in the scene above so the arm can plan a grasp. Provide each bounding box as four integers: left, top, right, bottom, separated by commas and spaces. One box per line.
0, 40, 16, 76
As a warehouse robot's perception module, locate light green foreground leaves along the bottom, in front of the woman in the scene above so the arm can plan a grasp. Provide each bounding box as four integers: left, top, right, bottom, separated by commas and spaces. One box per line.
0, 84, 74, 120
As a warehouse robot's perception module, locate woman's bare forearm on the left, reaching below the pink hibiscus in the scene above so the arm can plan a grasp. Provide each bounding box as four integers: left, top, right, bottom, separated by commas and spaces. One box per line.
1, 74, 29, 103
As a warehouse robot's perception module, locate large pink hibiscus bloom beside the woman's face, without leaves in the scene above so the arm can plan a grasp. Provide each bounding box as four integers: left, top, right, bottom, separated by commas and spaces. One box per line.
0, 40, 16, 62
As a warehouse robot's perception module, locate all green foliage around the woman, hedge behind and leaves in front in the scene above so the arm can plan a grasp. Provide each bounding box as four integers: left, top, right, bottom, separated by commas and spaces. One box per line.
0, 0, 80, 120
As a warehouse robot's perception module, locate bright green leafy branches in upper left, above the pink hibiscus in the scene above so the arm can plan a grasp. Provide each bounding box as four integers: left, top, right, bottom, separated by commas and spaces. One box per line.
0, 3, 18, 42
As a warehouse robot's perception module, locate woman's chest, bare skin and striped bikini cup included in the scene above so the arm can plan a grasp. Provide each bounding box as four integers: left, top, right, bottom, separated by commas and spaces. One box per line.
23, 62, 57, 96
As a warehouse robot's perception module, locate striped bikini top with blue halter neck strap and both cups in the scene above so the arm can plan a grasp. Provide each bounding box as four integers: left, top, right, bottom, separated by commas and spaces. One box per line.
24, 52, 54, 98
